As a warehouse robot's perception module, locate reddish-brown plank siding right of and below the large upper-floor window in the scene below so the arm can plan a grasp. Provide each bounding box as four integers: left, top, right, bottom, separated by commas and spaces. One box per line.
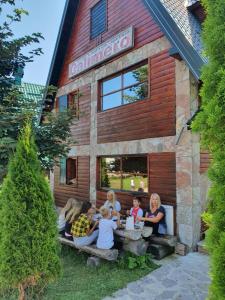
97, 50, 176, 143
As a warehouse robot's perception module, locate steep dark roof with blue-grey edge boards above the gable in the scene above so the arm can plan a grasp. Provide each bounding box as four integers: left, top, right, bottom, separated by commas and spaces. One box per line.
47, 0, 206, 86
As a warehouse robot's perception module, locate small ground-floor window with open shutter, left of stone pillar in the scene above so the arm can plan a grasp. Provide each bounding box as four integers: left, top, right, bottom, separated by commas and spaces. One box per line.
60, 158, 77, 184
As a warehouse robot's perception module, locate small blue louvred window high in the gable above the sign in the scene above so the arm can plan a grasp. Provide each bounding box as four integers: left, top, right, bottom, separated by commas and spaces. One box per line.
91, 0, 107, 39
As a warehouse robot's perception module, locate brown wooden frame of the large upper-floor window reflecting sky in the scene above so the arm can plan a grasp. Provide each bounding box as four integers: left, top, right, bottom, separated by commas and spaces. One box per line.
98, 59, 150, 112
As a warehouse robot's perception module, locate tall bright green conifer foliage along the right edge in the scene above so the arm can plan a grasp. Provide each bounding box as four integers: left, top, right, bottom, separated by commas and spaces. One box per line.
193, 0, 225, 300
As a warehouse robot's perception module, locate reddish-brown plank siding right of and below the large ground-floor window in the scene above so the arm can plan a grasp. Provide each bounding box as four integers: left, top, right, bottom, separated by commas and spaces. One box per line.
96, 152, 176, 212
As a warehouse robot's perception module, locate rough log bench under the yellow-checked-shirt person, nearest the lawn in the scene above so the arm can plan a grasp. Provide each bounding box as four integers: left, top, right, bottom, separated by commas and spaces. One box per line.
59, 236, 118, 261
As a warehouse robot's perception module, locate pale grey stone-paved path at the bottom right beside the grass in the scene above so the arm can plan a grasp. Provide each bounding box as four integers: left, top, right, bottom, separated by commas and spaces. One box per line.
104, 253, 210, 300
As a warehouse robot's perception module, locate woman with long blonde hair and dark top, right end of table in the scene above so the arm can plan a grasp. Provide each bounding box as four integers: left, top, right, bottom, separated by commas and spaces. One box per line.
137, 193, 166, 234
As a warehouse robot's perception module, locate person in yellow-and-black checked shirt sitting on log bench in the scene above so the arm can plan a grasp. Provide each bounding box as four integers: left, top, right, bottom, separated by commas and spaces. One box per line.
71, 201, 99, 248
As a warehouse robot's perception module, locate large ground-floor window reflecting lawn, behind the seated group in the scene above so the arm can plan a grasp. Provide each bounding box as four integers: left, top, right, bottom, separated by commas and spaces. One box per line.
100, 156, 148, 193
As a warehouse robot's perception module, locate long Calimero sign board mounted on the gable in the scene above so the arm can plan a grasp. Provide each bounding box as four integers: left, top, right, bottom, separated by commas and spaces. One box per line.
69, 27, 134, 78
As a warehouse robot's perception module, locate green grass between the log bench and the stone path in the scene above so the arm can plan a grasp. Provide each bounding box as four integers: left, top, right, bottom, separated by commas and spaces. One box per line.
0, 246, 157, 300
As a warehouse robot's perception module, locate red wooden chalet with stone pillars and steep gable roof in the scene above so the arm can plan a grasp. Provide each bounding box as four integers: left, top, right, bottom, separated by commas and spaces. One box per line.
45, 0, 208, 249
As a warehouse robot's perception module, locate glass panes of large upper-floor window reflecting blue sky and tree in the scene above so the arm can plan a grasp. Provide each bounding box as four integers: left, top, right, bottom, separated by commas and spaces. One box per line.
100, 63, 148, 110
